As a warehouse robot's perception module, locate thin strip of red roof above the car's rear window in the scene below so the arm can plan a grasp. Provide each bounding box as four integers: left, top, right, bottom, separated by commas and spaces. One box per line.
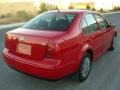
48, 10, 95, 14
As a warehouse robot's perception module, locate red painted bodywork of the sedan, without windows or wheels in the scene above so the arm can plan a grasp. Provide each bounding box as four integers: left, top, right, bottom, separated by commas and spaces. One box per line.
3, 10, 116, 79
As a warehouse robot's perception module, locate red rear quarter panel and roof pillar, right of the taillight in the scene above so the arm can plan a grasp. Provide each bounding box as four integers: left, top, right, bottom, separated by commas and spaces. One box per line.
53, 14, 83, 72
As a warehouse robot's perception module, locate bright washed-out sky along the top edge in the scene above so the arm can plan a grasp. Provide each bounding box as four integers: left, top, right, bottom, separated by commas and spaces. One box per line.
0, 0, 120, 8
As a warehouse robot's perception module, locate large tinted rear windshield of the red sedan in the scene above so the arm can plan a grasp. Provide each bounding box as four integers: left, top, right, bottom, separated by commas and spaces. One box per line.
23, 12, 76, 31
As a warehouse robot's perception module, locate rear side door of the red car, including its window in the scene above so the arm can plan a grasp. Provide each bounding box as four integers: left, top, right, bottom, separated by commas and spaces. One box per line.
82, 13, 104, 59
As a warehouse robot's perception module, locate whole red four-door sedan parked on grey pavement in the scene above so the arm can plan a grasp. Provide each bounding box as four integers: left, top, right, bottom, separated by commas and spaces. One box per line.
3, 10, 117, 81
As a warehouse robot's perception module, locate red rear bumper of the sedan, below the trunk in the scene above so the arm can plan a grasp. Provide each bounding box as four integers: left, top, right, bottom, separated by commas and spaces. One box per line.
3, 49, 70, 80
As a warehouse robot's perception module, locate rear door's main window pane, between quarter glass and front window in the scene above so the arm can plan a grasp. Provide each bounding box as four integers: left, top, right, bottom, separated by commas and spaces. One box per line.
85, 14, 98, 33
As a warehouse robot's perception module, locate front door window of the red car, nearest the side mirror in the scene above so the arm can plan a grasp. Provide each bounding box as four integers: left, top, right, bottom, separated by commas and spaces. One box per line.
94, 14, 109, 29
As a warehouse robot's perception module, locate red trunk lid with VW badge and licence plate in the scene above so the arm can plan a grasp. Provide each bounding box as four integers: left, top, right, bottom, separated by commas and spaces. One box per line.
5, 28, 62, 60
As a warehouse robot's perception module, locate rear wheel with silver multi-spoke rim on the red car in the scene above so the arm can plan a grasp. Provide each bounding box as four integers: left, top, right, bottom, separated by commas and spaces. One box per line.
76, 53, 92, 81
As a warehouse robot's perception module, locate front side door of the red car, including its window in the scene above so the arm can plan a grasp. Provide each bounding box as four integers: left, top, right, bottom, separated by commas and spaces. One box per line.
94, 13, 113, 51
